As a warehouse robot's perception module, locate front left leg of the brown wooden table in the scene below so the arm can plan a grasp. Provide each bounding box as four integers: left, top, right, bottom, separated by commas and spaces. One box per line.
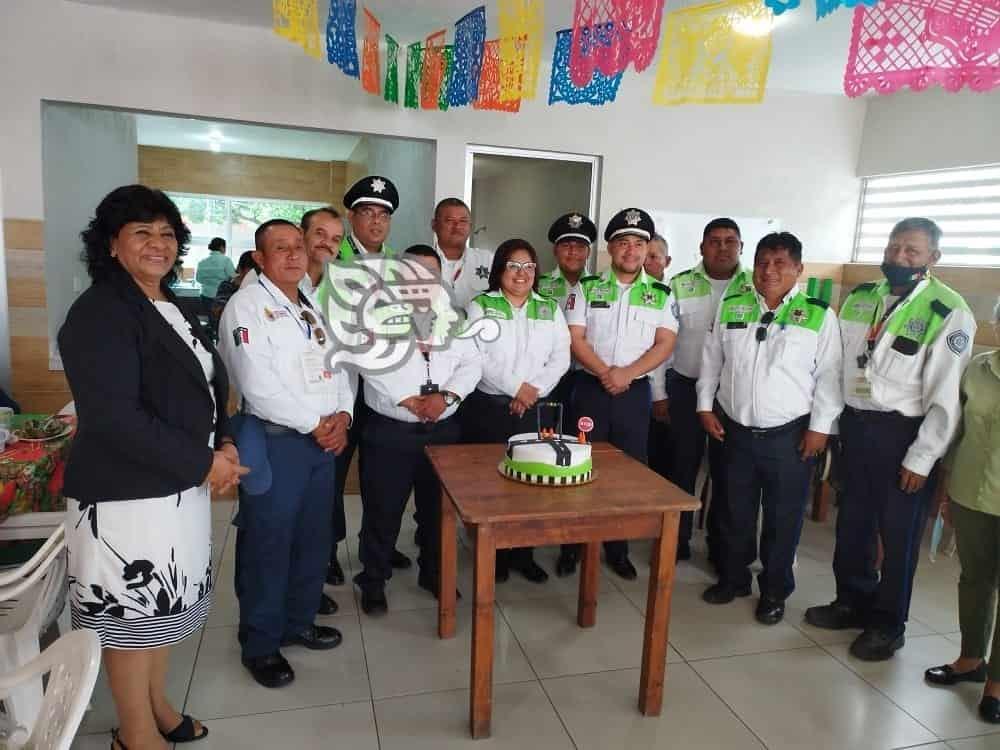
469, 524, 497, 740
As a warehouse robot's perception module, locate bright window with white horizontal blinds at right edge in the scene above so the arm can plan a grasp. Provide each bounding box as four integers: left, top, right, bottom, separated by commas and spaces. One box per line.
854, 165, 1000, 266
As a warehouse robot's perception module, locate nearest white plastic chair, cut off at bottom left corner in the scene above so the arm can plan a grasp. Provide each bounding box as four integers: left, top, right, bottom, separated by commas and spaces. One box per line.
0, 630, 101, 750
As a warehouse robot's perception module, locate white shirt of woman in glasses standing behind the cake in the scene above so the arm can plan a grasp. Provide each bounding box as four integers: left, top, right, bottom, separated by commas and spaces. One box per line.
468, 291, 570, 398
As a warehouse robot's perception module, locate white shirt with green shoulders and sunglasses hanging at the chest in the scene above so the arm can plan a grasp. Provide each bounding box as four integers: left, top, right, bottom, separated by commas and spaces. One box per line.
697, 287, 844, 435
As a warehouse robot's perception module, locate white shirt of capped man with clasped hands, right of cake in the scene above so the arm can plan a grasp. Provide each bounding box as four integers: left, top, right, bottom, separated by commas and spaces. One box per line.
566, 269, 677, 374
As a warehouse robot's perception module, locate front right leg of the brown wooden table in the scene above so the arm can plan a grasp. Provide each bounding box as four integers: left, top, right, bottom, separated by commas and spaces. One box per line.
639, 511, 680, 716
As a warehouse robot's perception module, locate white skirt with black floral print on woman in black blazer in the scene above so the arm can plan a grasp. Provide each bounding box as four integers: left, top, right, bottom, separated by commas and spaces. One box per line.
66, 486, 212, 649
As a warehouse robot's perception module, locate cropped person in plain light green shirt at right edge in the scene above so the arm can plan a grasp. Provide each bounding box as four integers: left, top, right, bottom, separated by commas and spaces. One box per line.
924, 299, 1000, 724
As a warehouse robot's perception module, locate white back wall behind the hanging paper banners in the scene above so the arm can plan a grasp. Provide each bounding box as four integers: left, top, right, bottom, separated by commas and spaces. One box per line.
0, 0, 865, 274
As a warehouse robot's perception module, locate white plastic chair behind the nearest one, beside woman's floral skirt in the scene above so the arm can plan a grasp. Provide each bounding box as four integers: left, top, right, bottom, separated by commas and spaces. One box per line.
0, 526, 66, 732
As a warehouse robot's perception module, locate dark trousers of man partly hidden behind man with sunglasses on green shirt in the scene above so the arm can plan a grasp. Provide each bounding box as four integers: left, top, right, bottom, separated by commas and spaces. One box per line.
667, 371, 728, 562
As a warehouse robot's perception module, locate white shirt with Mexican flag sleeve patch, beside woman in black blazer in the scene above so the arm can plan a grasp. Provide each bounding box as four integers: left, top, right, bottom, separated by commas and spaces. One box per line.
219, 274, 354, 434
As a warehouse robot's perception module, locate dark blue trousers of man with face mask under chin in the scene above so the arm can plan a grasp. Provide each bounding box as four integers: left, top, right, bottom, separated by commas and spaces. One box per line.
833, 407, 936, 633
